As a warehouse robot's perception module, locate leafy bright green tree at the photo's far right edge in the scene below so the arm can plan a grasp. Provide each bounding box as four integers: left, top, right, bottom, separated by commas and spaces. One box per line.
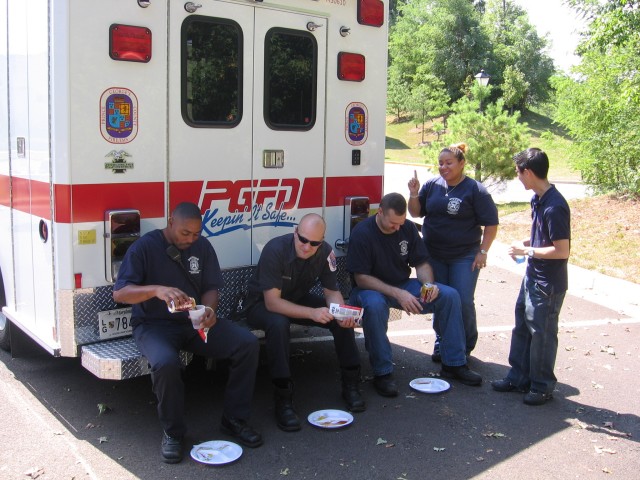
554, 0, 640, 196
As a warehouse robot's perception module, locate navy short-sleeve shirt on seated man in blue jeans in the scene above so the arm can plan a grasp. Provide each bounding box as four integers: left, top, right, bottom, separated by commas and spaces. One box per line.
347, 215, 429, 285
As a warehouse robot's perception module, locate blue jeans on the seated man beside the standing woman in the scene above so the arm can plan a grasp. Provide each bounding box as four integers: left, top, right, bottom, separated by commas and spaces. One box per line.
349, 278, 467, 376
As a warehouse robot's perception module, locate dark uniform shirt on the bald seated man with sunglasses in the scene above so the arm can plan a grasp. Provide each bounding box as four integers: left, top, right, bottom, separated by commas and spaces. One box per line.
248, 233, 338, 303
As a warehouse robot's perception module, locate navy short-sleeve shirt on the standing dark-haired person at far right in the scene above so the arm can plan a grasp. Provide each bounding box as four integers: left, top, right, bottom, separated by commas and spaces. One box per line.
527, 185, 571, 293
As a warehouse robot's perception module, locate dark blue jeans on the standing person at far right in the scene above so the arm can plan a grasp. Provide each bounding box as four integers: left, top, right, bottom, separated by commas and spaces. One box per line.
507, 276, 566, 393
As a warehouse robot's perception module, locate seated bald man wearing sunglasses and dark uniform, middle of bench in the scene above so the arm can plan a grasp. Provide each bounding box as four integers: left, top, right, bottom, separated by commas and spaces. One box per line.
246, 213, 366, 432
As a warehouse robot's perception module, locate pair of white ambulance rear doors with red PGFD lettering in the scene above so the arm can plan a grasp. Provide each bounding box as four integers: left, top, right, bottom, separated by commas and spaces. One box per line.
169, 1, 327, 268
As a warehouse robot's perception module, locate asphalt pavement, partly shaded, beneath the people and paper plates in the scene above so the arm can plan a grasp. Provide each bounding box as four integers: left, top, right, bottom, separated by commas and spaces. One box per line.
0, 166, 640, 480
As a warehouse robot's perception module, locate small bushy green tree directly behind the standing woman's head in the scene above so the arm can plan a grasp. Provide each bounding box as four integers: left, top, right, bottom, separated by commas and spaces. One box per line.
426, 98, 529, 186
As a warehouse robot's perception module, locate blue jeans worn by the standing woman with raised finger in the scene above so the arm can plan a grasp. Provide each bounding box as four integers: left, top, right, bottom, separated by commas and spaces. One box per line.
429, 252, 480, 353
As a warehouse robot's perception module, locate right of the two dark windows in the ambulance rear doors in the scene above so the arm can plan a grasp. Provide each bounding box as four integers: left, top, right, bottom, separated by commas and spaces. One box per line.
264, 28, 318, 130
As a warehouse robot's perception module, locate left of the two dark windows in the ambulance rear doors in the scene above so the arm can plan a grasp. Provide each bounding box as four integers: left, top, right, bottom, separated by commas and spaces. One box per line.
182, 16, 243, 127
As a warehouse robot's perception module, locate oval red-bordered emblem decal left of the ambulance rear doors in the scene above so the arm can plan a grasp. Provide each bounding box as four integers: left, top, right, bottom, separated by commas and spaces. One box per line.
100, 87, 138, 144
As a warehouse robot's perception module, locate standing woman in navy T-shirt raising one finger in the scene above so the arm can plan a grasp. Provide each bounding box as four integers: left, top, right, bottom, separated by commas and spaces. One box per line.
408, 143, 498, 362
